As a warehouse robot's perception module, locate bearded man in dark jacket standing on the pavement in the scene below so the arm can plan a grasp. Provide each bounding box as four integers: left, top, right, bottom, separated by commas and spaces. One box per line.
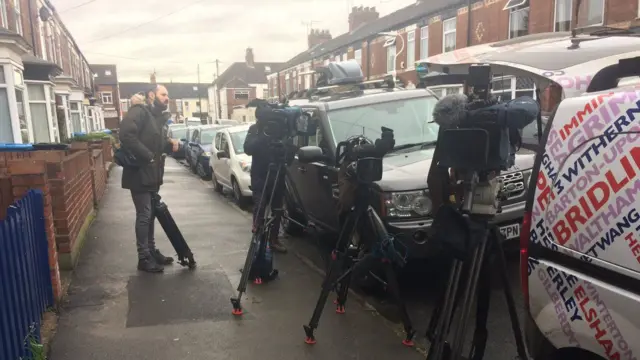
120, 85, 179, 272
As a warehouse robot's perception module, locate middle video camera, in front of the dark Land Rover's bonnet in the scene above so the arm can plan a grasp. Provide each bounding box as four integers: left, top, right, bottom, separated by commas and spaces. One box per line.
336, 126, 395, 185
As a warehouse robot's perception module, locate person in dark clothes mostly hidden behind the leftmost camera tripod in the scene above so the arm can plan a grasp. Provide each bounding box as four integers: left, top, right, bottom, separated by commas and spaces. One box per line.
244, 124, 287, 253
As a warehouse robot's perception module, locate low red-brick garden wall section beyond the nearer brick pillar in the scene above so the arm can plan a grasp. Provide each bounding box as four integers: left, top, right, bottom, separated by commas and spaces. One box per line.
47, 150, 94, 262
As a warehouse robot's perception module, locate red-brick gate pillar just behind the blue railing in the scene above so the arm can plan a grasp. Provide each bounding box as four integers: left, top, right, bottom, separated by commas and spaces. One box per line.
6, 158, 62, 301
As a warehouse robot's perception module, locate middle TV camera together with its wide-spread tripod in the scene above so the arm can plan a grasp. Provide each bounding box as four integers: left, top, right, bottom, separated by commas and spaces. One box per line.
298, 127, 415, 346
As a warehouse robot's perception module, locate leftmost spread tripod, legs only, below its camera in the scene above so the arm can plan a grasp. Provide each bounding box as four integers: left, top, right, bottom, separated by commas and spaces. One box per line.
230, 152, 306, 315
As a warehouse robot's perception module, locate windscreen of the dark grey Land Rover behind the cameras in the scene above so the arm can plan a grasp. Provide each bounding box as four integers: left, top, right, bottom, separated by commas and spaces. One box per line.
327, 96, 438, 152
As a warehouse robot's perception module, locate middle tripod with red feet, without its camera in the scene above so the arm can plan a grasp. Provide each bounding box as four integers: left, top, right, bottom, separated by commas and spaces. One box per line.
304, 185, 415, 346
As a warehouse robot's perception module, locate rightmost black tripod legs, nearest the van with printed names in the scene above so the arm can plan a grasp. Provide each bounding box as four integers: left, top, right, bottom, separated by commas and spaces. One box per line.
427, 210, 527, 360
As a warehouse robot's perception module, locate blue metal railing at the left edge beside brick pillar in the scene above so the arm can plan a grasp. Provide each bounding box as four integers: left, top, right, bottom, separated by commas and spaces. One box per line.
0, 190, 53, 360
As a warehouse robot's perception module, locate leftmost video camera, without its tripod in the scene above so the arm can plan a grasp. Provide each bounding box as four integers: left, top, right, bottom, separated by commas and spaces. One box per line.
247, 99, 315, 142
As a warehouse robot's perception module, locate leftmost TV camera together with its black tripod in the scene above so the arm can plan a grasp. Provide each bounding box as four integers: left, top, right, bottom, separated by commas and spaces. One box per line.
231, 99, 315, 315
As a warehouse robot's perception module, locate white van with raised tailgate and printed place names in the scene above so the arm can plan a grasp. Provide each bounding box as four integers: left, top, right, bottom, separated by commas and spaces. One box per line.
422, 33, 640, 360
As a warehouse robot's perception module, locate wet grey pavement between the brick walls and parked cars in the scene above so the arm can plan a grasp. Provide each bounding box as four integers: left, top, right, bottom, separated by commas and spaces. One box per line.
50, 159, 424, 360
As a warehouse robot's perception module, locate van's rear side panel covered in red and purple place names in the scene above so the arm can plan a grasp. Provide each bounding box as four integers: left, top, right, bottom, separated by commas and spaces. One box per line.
520, 54, 640, 360
